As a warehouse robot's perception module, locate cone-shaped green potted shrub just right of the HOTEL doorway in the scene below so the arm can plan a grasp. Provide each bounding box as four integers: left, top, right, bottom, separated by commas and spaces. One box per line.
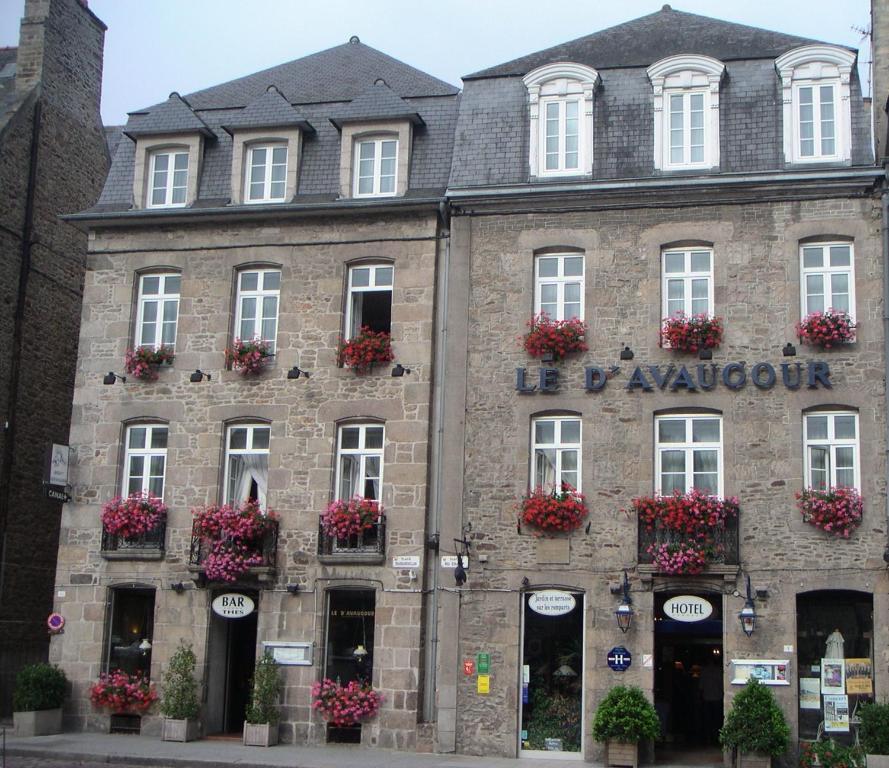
719, 678, 790, 768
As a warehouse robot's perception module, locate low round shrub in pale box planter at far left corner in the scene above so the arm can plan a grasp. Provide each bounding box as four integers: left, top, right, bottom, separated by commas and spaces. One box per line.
12, 663, 68, 736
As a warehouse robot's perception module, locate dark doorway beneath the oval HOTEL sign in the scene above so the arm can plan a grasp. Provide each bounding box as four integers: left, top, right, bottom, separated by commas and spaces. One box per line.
654, 592, 725, 764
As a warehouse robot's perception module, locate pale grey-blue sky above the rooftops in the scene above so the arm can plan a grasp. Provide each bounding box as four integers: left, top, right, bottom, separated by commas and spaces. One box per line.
0, 0, 870, 124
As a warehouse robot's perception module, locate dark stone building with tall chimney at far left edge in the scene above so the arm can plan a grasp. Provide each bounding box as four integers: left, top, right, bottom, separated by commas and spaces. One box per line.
0, 0, 108, 716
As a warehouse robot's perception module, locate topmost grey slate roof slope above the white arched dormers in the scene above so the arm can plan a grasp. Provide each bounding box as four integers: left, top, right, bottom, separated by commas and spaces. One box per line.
463, 5, 836, 81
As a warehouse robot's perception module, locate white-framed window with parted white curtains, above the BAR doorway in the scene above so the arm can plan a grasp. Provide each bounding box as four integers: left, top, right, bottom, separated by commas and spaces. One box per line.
224, 424, 271, 509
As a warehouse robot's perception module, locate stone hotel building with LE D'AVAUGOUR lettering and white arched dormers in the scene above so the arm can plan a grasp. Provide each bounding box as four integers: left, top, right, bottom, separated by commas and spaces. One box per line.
437, 6, 889, 762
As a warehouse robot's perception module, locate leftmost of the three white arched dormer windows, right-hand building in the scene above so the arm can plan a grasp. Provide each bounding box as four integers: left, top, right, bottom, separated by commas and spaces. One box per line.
524, 62, 599, 176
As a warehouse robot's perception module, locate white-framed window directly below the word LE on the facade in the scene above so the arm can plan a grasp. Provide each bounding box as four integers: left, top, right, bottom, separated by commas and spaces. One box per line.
531, 416, 582, 492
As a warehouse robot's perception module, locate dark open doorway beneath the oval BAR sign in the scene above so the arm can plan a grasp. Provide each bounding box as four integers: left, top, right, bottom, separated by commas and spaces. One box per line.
205, 590, 259, 734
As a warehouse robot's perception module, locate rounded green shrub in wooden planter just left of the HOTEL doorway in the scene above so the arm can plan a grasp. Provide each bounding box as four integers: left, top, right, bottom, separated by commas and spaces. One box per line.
593, 685, 661, 768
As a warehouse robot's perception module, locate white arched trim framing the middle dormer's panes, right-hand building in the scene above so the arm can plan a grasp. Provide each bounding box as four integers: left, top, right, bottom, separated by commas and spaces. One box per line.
647, 54, 725, 171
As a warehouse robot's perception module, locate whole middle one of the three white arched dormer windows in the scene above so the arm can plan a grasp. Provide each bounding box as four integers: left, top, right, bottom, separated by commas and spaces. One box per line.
647, 54, 725, 171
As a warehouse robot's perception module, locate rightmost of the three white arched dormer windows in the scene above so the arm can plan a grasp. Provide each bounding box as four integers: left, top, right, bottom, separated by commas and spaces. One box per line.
775, 45, 855, 163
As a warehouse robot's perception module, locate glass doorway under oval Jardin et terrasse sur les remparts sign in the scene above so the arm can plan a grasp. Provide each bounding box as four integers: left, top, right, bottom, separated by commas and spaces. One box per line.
519, 589, 584, 760
